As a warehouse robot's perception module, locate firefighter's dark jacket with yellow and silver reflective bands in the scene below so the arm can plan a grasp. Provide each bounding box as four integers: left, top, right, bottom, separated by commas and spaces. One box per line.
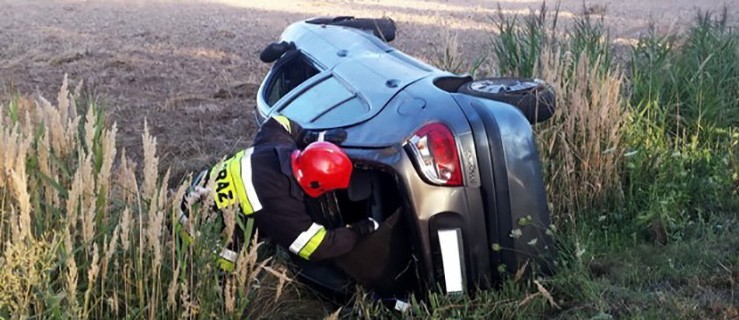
180, 116, 358, 262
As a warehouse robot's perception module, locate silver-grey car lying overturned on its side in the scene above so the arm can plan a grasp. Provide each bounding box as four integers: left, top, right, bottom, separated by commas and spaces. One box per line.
256, 17, 554, 295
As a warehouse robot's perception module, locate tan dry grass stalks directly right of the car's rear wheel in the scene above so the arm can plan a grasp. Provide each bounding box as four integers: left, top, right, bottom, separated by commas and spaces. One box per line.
537, 49, 629, 221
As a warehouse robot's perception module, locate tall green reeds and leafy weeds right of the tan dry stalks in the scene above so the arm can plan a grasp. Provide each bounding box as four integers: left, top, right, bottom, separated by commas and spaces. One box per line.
625, 11, 739, 243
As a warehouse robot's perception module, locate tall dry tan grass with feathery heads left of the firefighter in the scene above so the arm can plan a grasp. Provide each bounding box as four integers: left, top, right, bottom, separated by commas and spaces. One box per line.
0, 78, 294, 319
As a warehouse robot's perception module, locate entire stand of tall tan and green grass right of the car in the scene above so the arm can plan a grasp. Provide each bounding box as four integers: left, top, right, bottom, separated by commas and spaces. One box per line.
492, 5, 739, 242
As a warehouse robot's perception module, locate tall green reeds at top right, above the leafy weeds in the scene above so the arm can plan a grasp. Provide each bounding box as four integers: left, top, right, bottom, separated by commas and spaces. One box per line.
630, 9, 739, 135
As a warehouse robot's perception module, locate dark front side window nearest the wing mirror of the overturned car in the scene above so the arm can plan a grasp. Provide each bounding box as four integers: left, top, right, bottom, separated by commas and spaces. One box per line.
265, 55, 319, 106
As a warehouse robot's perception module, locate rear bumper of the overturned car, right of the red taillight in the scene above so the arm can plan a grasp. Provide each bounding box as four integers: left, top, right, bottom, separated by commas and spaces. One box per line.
458, 96, 554, 281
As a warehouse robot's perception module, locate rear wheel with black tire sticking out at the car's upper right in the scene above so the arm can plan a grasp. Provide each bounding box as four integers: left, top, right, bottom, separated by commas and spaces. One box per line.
459, 78, 557, 124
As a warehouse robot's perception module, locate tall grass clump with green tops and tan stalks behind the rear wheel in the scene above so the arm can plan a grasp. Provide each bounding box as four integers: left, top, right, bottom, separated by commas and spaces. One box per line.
491, 3, 629, 225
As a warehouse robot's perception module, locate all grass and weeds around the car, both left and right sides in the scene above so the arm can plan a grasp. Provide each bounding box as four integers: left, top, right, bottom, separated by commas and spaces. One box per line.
0, 6, 739, 319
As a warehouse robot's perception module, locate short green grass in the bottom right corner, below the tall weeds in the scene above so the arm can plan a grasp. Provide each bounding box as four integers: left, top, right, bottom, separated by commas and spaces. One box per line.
547, 211, 739, 319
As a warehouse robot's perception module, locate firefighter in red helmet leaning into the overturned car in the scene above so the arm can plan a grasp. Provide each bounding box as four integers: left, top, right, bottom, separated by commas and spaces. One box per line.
178, 115, 378, 270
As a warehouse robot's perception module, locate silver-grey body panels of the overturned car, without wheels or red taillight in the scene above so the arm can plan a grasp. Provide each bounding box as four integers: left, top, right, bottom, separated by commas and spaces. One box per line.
256, 22, 552, 293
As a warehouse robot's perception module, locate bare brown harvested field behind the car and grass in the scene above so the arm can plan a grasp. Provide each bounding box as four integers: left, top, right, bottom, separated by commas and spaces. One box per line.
0, 0, 739, 181
